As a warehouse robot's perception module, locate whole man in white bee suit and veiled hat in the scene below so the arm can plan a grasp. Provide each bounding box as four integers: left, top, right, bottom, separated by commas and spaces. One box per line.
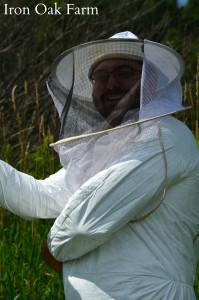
0, 32, 199, 300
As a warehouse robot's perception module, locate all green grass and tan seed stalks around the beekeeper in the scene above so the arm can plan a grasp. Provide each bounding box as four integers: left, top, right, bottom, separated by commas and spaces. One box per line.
0, 64, 199, 300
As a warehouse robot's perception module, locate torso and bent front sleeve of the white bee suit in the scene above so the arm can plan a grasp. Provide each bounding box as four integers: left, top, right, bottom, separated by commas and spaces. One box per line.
48, 117, 199, 300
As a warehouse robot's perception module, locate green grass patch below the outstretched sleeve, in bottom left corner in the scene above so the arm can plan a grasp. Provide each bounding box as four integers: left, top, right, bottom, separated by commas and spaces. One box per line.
0, 214, 64, 300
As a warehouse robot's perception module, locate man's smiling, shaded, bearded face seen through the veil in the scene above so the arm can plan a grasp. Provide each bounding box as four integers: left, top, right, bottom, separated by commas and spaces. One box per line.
91, 58, 142, 118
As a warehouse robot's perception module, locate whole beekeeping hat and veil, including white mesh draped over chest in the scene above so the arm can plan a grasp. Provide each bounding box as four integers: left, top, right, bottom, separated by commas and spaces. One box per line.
47, 32, 189, 190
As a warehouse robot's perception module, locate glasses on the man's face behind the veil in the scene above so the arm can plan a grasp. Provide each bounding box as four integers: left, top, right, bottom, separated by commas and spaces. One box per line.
91, 66, 142, 83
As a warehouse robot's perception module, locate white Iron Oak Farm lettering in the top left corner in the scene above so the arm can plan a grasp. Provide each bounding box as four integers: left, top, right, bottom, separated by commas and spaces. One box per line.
4, 2, 99, 15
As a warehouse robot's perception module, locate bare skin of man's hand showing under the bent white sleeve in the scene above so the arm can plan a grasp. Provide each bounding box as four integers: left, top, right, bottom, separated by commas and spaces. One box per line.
41, 240, 62, 274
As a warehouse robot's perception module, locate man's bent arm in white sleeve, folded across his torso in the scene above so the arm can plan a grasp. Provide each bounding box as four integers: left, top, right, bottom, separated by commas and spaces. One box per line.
47, 119, 199, 262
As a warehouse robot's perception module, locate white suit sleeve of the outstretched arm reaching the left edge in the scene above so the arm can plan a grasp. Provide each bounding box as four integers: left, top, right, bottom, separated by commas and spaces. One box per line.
0, 161, 70, 219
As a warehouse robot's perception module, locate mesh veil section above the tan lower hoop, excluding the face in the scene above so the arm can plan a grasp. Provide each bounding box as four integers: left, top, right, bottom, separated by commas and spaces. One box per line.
47, 38, 186, 146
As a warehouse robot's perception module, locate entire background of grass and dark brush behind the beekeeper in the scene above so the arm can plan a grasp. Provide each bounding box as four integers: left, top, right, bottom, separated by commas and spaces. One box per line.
0, 0, 199, 300
